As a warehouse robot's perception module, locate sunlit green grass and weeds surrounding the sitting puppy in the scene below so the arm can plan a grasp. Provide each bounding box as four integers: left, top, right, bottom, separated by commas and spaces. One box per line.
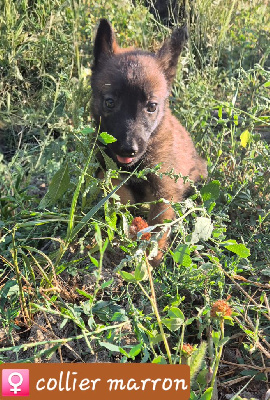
0, 0, 270, 399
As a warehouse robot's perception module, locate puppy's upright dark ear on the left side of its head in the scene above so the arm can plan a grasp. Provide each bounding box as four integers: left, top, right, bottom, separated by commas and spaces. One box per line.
94, 18, 118, 68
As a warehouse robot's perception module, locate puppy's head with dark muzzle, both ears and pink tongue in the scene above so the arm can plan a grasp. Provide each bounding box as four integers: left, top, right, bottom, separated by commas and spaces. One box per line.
92, 19, 187, 167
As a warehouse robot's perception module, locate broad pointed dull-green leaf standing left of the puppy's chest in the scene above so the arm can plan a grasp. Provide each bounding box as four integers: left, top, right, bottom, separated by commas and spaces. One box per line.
39, 163, 70, 208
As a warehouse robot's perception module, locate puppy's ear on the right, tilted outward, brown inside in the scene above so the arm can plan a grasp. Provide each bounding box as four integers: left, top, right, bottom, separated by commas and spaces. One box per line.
156, 25, 188, 85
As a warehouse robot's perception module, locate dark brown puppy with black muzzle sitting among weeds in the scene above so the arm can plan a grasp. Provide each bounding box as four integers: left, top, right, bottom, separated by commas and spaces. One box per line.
92, 19, 207, 265
